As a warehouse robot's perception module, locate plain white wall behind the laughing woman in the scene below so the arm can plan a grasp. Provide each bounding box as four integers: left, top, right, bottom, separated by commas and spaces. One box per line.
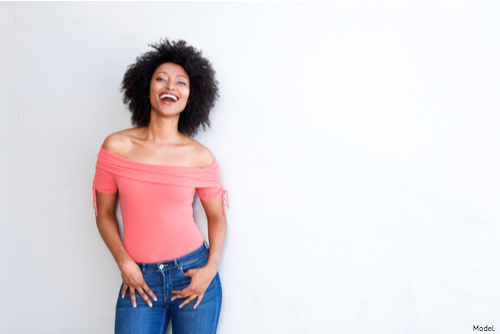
0, 2, 500, 334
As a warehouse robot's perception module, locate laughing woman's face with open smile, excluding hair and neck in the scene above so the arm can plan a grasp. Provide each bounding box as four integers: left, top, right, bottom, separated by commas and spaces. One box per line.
149, 63, 189, 116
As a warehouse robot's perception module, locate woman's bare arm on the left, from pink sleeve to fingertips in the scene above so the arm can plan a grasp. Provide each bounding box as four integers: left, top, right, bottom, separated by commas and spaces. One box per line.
95, 190, 157, 307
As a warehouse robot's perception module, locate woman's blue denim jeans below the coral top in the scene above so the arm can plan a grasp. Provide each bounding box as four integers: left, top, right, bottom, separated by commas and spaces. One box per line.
115, 244, 222, 334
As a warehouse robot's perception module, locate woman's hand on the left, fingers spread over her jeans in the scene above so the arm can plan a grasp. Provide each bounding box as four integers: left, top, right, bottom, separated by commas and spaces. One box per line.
121, 261, 157, 307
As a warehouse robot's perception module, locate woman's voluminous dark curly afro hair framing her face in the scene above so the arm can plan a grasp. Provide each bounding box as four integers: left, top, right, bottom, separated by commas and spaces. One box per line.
121, 39, 219, 136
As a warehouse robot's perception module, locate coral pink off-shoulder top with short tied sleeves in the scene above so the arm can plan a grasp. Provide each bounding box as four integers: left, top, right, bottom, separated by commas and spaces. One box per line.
92, 147, 227, 263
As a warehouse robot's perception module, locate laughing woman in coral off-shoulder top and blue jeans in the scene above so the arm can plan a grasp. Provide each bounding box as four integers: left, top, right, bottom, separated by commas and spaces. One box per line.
93, 40, 226, 334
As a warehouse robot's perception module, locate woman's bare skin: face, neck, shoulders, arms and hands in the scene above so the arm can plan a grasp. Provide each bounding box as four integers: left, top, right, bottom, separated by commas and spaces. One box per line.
96, 63, 226, 309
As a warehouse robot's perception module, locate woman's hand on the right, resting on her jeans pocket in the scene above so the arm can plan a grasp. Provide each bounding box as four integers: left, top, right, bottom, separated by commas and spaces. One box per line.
171, 267, 217, 309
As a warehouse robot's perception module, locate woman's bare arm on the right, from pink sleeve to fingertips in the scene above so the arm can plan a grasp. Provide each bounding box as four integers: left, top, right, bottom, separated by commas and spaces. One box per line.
172, 195, 227, 309
